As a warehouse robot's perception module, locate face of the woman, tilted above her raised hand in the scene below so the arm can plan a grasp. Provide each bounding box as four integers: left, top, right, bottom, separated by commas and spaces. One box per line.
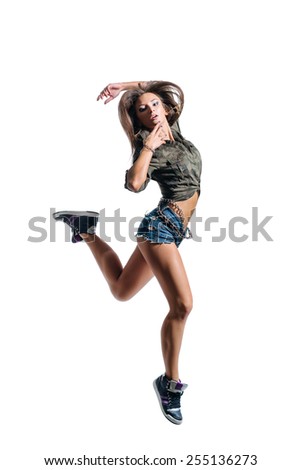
135, 93, 168, 129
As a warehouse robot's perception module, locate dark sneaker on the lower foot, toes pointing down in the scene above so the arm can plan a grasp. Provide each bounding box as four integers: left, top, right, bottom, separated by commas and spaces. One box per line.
153, 375, 188, 424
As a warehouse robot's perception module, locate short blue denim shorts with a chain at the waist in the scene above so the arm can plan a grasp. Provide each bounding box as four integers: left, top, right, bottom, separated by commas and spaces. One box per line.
136, 206, 191, 247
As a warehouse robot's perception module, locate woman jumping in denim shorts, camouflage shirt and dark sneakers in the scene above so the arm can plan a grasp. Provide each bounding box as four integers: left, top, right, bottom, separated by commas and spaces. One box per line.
53, 81, 202, 424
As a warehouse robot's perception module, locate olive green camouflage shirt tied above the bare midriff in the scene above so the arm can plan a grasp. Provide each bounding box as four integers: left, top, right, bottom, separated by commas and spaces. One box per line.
124, 122, 202, 201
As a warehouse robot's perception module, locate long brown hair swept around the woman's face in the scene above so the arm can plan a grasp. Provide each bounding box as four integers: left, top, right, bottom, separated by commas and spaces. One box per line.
118, 81, 184, 150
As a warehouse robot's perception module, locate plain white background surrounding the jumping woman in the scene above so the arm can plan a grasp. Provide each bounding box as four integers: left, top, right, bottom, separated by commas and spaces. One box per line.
0, 0, 301, 470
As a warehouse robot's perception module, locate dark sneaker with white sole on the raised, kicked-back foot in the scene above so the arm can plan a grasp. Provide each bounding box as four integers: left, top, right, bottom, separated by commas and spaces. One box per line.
52, 211, 99, 243
